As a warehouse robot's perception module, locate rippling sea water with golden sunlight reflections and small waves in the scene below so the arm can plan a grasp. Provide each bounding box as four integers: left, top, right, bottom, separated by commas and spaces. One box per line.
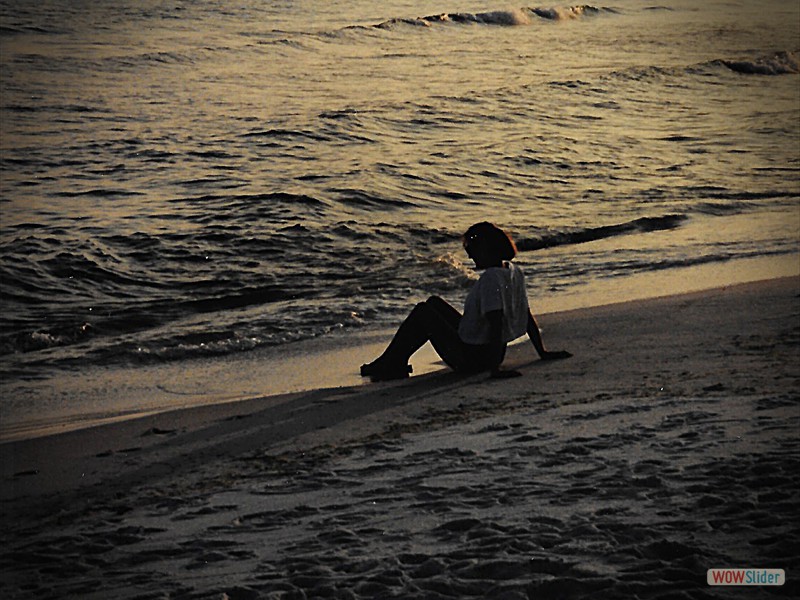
0, 0, 800, 436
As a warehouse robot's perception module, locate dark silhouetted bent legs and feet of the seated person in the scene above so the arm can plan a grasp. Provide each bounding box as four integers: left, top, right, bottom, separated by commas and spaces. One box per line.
361, 297, 464, 378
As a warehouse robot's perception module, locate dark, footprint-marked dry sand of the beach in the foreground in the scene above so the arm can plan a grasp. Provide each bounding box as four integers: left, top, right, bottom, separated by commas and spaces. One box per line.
0, 277, 800, 600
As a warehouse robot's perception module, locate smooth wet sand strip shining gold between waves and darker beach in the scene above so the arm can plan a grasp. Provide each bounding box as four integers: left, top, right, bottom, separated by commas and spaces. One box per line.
0, 255, 800, 447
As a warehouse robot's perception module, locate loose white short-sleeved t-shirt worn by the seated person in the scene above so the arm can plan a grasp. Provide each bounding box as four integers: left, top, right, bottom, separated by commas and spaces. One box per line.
458, 262, 529, 344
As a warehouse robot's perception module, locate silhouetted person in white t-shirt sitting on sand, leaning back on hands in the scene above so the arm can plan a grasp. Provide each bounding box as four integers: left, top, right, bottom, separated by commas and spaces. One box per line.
361, 222, 572, 381
